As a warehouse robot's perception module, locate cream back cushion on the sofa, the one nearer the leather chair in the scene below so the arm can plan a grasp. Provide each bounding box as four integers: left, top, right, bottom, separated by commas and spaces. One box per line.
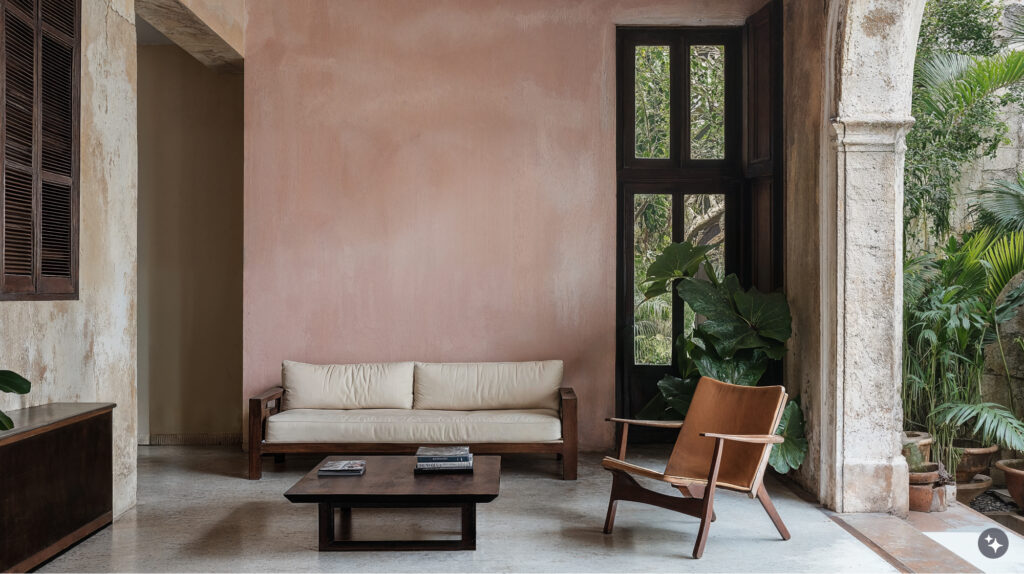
414, 361, 562, 410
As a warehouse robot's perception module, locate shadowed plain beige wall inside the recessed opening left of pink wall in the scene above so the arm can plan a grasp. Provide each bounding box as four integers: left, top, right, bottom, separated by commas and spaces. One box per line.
138, 45, 243, 443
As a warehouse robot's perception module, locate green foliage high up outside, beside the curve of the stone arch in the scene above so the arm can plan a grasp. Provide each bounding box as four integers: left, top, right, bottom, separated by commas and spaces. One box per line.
903, 0, 1024, 248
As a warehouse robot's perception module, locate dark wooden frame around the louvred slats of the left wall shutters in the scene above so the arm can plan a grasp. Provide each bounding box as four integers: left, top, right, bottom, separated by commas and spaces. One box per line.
0, 0, 82, 301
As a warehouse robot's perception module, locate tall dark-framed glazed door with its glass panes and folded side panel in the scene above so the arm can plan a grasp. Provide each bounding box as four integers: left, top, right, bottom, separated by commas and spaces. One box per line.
616, 0, 784, 433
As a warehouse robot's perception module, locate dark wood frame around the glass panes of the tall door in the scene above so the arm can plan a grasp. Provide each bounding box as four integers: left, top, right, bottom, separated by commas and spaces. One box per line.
615, 27, 749, 429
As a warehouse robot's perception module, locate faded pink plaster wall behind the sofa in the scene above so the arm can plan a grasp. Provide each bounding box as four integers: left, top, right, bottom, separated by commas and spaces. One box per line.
243, 0, 764, 449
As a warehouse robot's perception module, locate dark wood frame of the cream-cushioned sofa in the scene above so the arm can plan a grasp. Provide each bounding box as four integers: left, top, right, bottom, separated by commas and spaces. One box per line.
249, 387, 579, 480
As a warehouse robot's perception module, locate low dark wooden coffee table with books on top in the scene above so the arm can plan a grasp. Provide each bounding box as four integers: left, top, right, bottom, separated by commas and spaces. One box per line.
285, 456, 502, 551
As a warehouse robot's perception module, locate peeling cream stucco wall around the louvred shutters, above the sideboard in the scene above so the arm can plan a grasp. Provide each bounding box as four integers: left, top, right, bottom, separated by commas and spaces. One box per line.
0, 0, 137, 515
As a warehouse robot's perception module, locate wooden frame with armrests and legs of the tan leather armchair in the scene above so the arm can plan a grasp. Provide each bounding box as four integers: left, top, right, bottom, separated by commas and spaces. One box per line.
602, 413, 790, 559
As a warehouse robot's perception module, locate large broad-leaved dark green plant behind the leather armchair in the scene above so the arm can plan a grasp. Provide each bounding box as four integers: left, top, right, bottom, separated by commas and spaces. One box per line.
637, 241, 807, 473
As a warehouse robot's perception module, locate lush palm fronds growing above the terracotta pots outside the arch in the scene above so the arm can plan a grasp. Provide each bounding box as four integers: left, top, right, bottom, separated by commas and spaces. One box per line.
902, 229, 1024, 474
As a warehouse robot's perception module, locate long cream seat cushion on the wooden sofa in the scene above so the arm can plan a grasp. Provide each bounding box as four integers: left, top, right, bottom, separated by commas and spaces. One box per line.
266, 408, 562, 444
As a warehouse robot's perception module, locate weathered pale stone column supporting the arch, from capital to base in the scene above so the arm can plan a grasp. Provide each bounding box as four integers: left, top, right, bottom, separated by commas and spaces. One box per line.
822, 118, 913, 515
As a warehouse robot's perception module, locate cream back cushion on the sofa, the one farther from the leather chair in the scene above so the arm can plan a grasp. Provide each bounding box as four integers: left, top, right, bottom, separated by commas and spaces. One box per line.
281, 361, 413, 409
